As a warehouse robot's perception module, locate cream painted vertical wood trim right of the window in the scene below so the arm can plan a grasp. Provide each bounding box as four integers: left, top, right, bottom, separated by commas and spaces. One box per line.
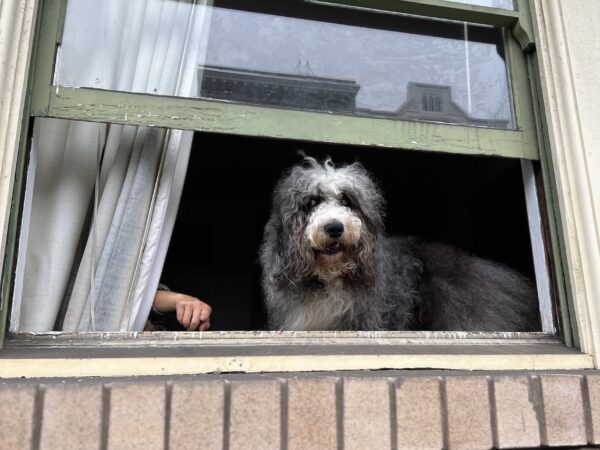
531, 0, 600, 367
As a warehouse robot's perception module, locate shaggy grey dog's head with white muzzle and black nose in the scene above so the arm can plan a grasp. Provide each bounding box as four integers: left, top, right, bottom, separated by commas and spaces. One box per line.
272, 158, 383, 282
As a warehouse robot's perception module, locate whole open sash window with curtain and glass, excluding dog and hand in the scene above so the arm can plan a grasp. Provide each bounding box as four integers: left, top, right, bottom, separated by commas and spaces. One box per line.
4, 0, 588, 374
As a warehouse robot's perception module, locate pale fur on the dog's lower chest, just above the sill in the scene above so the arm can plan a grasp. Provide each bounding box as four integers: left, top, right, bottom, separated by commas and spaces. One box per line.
284, 279, 353, 330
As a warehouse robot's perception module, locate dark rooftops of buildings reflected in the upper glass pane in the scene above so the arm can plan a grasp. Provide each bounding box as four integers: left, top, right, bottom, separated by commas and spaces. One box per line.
198, 66, 509, 128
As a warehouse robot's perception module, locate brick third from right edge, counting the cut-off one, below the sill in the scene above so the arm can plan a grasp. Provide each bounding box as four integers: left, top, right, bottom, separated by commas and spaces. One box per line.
494, 376, 541, 448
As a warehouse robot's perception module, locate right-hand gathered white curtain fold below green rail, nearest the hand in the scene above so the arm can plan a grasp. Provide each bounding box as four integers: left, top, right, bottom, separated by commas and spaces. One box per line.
63, 128, 165, 331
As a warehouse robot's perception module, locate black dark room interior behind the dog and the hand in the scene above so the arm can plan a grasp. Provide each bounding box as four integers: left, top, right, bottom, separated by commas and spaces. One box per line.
157, 133, 533, 330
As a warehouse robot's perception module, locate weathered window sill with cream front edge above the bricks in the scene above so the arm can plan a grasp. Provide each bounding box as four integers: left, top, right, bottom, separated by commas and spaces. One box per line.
0, 331, 594, 378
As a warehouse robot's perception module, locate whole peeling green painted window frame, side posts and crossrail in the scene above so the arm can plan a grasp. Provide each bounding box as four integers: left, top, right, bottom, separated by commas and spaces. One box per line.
0, 0, 578, 346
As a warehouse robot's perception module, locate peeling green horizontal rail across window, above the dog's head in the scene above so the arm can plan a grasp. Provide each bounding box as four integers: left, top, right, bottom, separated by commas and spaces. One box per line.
42, 87, 539, 160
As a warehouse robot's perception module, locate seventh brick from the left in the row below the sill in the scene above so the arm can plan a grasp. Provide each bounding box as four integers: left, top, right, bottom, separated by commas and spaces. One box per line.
344, 378, 391, 450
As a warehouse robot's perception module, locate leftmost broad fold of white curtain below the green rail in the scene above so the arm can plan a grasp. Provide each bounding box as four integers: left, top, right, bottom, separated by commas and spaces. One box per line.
15, 119, 105, 331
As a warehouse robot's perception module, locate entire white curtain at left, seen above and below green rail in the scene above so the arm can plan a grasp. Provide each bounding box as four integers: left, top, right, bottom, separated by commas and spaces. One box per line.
11, 0, 211, 331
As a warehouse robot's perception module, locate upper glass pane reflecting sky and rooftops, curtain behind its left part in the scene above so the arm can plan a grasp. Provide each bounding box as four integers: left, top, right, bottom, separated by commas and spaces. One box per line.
57, 0, 512, 128
